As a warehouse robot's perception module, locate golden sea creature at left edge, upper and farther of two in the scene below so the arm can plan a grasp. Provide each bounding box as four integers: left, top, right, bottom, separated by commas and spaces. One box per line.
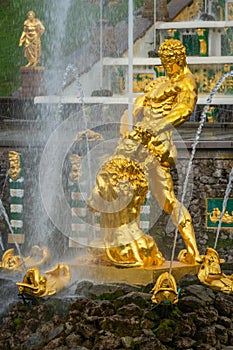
0, 245, 51, 271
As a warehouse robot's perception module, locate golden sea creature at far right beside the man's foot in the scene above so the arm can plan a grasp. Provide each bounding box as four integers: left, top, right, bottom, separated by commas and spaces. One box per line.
198, 248, 233, 294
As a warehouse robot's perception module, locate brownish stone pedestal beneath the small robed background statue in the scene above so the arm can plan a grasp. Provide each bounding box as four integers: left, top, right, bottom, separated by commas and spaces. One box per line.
20, 67, 45, 98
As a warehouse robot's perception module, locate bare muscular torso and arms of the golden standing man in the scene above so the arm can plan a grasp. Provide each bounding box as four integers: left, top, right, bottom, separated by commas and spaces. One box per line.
129, 68, 197, 163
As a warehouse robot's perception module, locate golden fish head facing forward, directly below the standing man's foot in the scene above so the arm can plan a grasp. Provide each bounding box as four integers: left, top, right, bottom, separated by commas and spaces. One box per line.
151, 272, 179, 304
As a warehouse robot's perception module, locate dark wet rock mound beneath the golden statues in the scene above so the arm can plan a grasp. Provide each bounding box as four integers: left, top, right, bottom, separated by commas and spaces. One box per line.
0, 278, 233, 350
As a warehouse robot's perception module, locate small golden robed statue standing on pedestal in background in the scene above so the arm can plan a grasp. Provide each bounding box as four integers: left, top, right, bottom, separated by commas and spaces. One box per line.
19, 11, 45, 68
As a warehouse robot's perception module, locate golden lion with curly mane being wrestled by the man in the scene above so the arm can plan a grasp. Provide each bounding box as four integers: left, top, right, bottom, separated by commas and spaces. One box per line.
89, 157, 165, 267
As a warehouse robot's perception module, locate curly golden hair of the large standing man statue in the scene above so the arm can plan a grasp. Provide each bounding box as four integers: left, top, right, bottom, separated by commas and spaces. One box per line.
158, 39, 186, 65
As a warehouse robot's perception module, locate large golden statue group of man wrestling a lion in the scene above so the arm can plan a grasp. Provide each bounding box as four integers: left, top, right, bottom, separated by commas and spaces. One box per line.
88, 39, 202, 267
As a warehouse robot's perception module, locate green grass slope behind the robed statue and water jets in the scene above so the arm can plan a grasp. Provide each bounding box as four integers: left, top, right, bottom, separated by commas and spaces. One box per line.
0, 0, 144, 96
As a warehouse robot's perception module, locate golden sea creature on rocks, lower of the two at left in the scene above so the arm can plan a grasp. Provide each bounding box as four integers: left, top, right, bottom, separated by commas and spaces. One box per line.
16, 264, 71, 298
